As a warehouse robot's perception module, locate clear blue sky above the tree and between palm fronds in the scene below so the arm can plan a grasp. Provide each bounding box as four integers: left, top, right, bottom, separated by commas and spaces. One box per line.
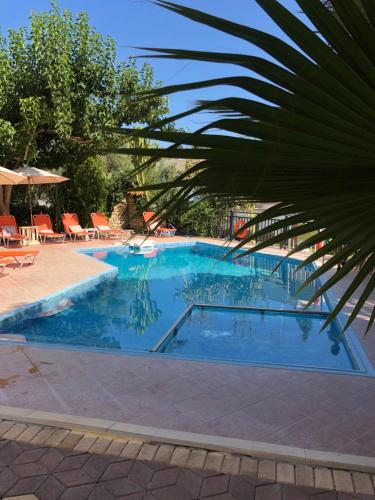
0, 0, 303, 130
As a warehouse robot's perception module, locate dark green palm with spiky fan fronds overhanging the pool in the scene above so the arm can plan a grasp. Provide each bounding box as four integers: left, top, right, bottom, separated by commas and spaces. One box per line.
110, 0, 375, 329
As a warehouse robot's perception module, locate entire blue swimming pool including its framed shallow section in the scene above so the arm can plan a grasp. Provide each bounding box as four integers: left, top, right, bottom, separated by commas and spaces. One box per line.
0, 242, 372, 371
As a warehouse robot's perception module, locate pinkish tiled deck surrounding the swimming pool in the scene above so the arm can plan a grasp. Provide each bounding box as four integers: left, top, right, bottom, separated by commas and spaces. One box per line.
0, 238, 375, 457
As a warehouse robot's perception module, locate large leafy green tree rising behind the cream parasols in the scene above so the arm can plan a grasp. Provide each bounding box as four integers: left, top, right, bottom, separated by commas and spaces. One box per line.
0, 1, 168, 213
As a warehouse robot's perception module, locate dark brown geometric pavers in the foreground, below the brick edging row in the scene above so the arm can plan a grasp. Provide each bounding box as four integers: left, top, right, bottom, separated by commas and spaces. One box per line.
0, 436, 374, 500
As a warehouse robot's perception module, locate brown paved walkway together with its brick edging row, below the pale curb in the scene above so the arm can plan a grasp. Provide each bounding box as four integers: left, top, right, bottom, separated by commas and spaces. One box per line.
0, 423, 374, 500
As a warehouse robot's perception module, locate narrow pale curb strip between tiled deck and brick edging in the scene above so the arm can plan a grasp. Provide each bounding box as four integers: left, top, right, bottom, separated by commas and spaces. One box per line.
0, 405, 375, 473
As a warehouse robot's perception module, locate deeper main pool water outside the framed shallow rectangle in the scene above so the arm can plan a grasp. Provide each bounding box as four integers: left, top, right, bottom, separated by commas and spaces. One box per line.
1, 243, 350, 368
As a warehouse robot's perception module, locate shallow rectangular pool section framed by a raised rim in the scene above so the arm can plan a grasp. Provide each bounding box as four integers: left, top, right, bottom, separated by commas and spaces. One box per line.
157, 306, 359, 371
